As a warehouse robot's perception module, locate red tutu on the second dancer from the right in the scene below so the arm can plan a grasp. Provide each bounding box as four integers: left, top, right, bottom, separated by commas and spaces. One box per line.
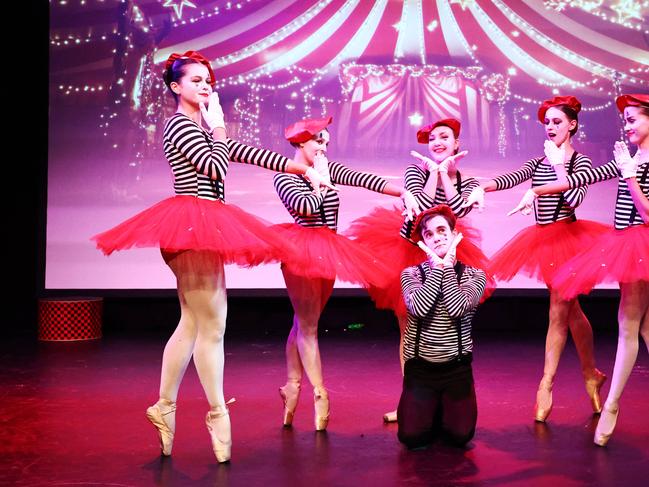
490, 220, 610, 286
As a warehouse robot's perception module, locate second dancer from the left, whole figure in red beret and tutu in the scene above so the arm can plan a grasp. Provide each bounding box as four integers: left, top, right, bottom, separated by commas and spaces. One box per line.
275, 117, 419, 431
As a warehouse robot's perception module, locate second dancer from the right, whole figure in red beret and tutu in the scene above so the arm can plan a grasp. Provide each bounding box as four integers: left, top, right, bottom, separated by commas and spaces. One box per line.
470, 96, 607, 422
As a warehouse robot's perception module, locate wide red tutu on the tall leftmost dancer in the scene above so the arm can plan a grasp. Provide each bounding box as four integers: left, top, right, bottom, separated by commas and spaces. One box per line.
92, 196, 294, 266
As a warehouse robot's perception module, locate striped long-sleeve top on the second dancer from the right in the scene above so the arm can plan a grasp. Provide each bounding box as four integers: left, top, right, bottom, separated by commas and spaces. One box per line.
494, 152, 593, 225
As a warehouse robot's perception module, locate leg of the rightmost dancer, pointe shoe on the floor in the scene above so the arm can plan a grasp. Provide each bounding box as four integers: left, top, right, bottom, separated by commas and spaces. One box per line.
594, 281, 649, 446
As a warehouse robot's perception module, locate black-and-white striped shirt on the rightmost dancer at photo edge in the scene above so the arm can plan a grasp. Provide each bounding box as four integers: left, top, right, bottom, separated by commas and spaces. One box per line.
568, 161, 649, 230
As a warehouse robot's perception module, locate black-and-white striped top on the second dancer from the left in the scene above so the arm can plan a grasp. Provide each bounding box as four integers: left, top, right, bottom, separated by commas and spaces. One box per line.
273, 161, 388, 231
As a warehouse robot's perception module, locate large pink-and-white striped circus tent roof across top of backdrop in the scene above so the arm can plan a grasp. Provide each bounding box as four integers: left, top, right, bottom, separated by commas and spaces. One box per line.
51, 0, 649, 99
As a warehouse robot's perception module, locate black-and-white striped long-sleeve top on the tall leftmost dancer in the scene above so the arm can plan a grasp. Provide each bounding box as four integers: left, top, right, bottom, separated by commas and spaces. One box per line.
163, 113, 289, 201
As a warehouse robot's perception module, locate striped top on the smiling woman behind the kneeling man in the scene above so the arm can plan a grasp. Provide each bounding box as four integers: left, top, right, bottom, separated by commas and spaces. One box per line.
399, 164, 479, 240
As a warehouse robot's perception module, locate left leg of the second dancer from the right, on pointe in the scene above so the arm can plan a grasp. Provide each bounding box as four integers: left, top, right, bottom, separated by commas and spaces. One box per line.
534, 290, 571, 422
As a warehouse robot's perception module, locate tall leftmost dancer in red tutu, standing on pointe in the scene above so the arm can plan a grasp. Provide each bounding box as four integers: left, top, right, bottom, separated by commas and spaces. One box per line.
93, 51, 330, 462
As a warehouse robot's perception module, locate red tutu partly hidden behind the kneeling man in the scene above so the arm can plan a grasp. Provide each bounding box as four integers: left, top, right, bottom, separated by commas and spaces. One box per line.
345, 207, 496, 316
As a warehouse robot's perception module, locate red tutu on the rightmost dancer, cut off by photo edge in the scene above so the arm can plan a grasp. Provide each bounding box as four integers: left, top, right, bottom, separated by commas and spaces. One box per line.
552, 224, 649, 299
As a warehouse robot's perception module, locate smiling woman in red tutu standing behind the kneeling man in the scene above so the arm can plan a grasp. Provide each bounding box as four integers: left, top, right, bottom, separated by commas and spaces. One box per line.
347, 118, 488, 422
